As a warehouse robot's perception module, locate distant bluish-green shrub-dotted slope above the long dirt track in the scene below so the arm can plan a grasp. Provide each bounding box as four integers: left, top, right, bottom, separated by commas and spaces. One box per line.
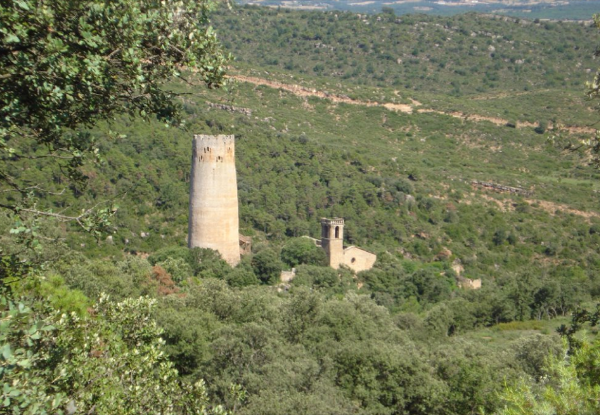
214, 7, 593, 96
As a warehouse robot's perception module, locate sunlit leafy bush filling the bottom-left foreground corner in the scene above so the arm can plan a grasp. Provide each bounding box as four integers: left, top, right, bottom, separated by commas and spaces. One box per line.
0, 297, 224, 414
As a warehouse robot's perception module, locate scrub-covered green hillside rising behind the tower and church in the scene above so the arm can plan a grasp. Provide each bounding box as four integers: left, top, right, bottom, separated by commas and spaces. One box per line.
2, 4, 600, 321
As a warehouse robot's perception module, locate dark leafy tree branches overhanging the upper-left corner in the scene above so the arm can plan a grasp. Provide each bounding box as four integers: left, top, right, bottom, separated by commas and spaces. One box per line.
0, 0, 228, 239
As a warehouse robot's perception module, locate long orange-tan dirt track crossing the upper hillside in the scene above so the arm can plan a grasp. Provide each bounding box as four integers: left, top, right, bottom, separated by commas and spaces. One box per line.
230, 75, 596, 134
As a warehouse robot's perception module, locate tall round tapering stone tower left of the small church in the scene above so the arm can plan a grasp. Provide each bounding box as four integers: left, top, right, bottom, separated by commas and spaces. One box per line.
188, 135, 240, 266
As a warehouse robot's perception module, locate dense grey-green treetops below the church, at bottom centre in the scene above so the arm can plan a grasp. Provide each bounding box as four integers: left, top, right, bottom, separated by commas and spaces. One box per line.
42, 254, 560, 414
